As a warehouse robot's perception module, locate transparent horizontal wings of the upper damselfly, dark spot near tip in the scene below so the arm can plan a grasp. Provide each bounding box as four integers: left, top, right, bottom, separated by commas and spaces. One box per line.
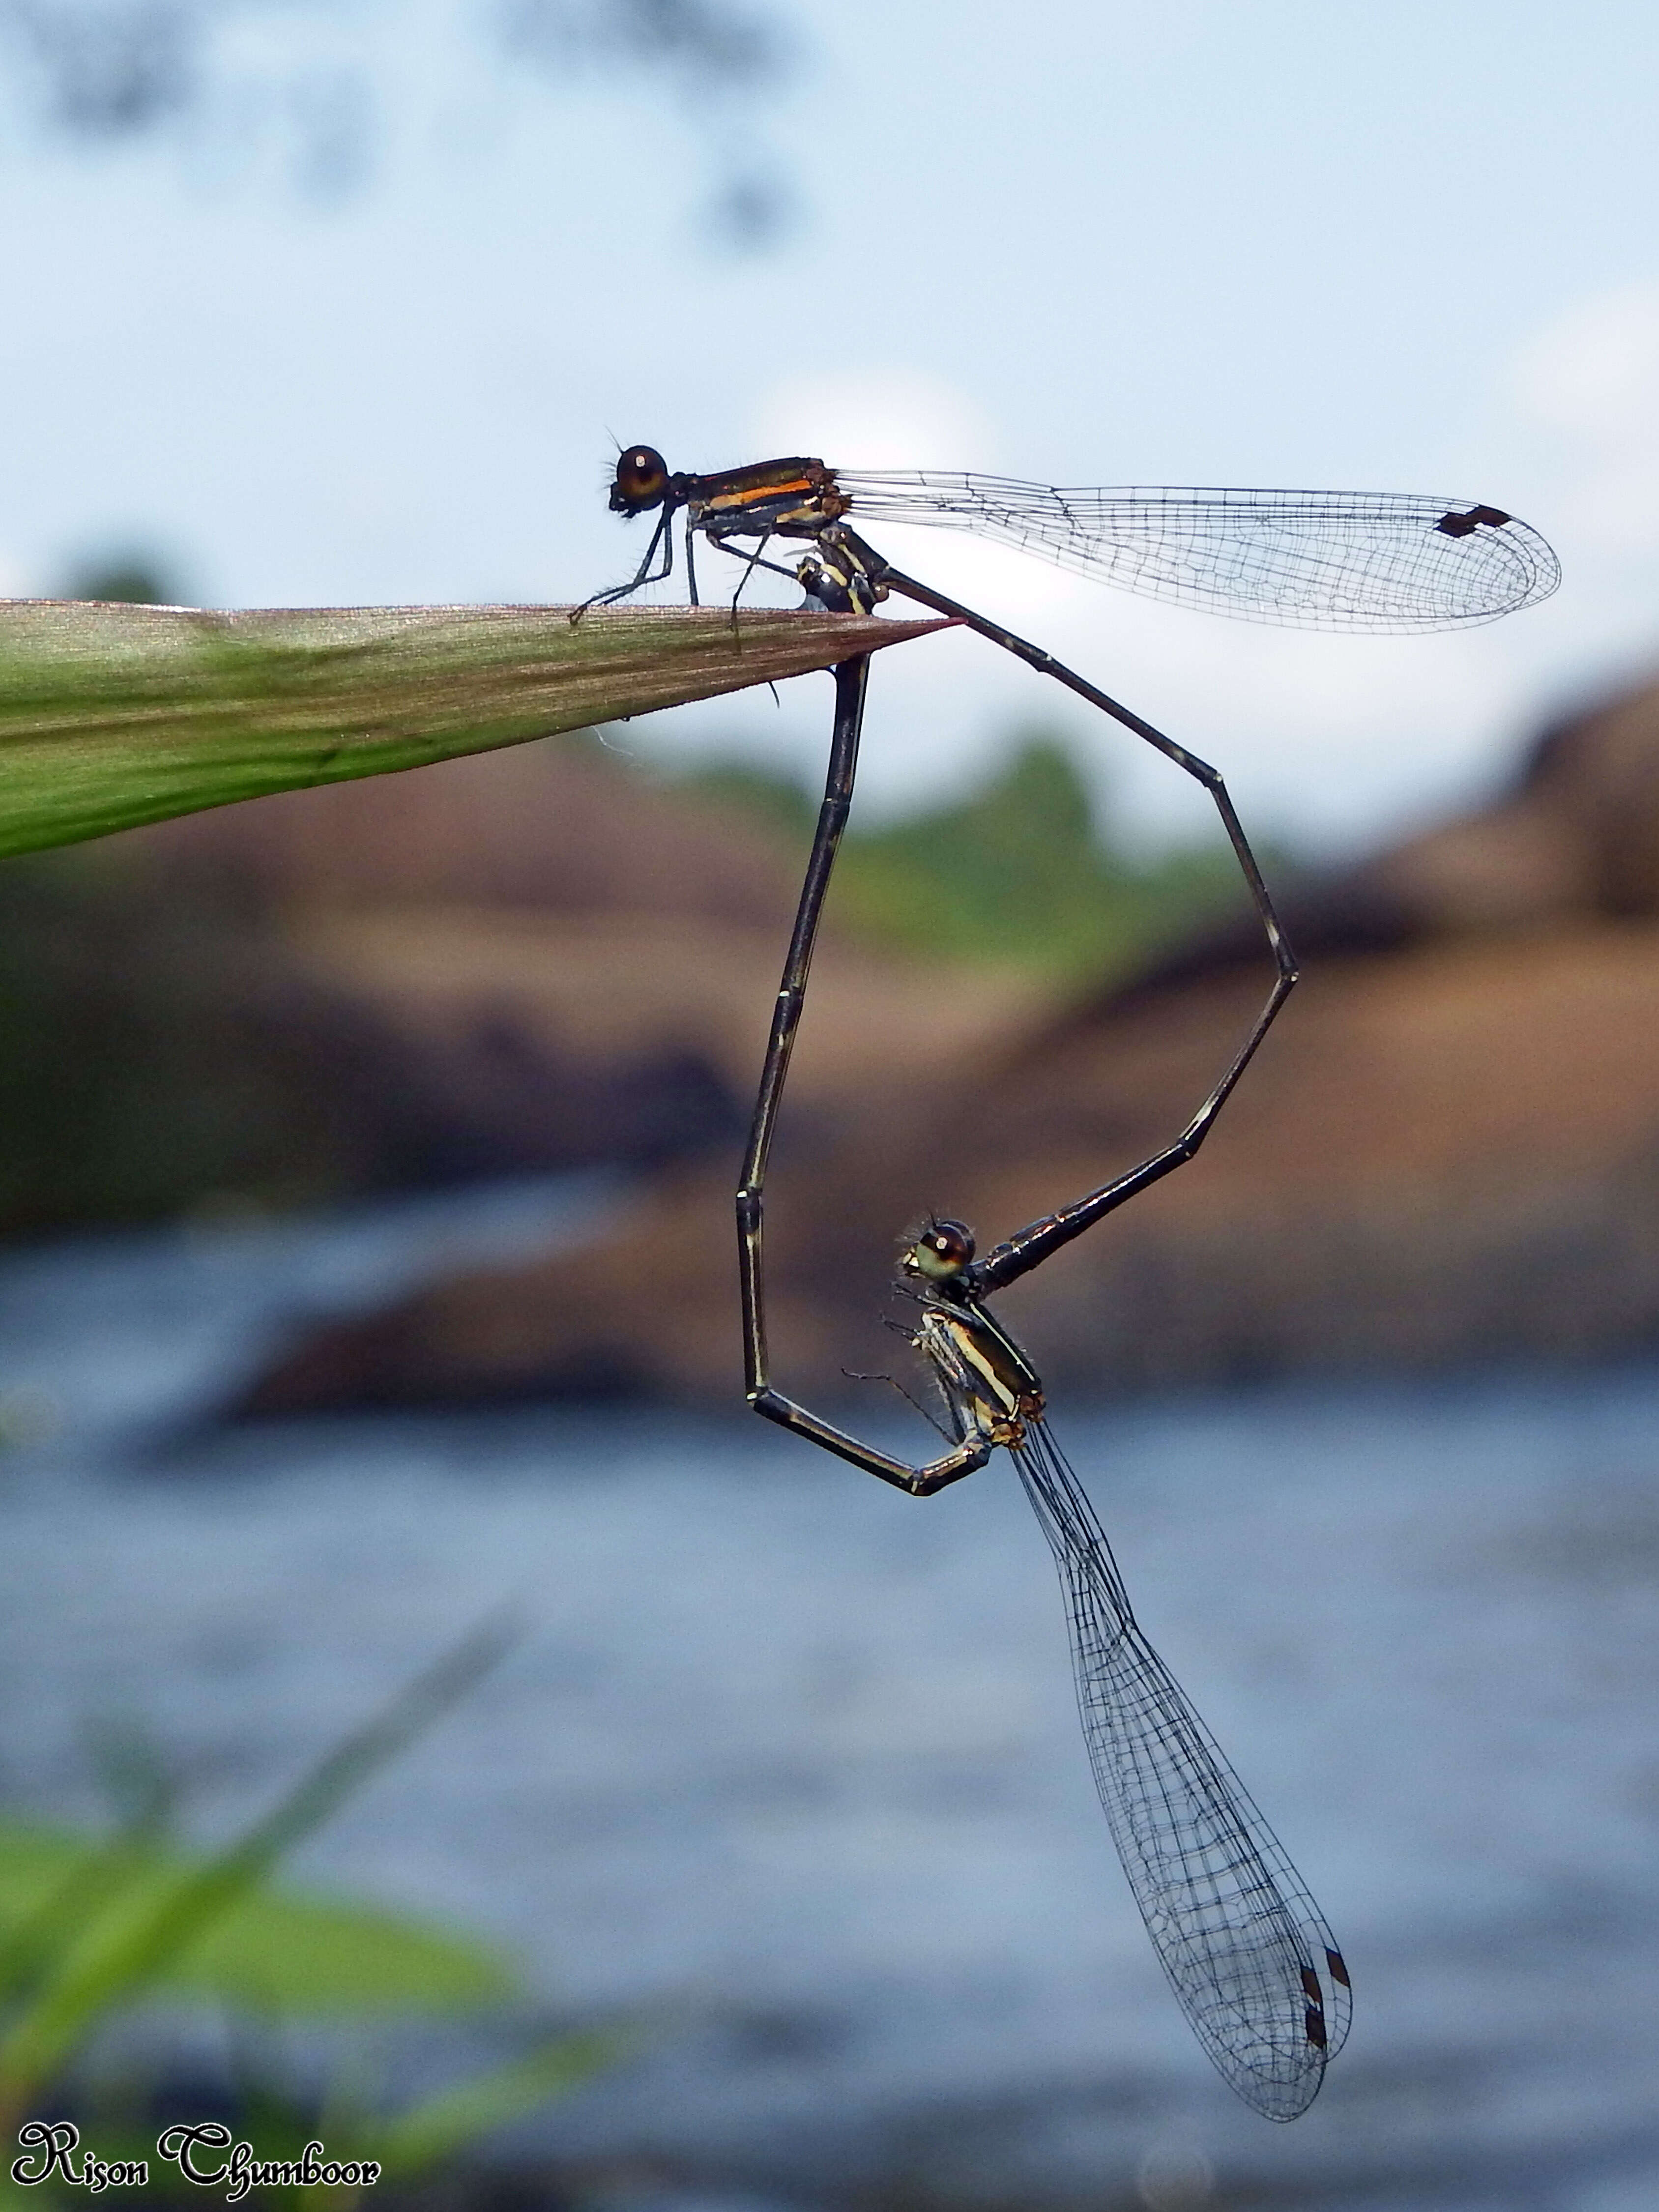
836, 469, 1562, 631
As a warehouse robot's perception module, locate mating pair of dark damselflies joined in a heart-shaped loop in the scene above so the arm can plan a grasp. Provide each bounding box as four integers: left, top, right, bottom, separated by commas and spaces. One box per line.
588, 447, 1560, 2119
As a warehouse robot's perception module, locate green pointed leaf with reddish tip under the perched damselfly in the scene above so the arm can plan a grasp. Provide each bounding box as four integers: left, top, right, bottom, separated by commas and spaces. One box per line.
0, 600, 940, 854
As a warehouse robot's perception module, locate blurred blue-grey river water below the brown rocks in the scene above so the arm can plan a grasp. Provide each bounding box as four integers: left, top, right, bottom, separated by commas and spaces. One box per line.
0, 1184, 1659, 2212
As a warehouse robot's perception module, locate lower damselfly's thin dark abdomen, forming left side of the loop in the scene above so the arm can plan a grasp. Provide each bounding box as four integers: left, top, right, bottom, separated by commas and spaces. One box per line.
737, 655, 993, 1498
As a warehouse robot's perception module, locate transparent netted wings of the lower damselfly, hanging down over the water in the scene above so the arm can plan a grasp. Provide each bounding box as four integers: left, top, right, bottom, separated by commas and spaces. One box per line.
1013, 1420, 1352, 2119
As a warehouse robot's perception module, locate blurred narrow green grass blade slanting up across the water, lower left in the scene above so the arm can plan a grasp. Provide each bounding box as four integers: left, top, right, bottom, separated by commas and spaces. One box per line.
0, 1622, 516, 2106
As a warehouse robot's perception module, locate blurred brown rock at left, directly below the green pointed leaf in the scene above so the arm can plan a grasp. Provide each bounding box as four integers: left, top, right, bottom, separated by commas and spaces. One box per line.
0, 741, 1053, 1232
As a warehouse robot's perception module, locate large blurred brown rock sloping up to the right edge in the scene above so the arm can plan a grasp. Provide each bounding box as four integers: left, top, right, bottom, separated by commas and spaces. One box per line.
246, 664, 1659, 1411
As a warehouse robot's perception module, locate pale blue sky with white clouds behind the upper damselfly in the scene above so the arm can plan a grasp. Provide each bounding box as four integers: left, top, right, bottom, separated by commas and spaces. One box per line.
0, 0, 1659, 849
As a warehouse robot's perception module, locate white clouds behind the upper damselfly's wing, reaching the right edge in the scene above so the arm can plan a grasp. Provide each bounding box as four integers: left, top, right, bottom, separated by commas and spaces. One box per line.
681, 320, 1659, 849
